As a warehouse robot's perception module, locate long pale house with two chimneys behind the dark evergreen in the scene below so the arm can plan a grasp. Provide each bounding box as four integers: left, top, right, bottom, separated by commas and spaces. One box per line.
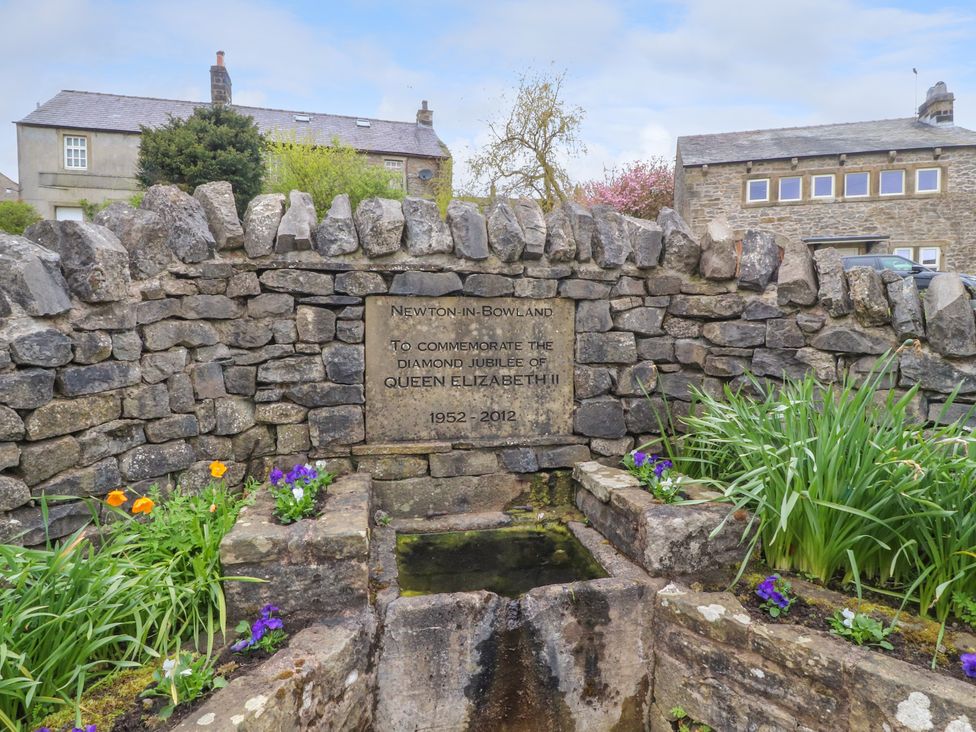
16, 51, 450, 220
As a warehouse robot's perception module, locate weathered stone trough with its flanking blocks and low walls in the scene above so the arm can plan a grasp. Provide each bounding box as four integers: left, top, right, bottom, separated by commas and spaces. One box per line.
175, 463, 976, 732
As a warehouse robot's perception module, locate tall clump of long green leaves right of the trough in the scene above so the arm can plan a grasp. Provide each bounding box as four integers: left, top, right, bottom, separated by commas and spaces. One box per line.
676, 346, 976, 627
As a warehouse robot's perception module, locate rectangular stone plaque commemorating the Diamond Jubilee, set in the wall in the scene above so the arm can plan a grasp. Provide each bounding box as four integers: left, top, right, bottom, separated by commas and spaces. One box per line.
366, 296, 574, 442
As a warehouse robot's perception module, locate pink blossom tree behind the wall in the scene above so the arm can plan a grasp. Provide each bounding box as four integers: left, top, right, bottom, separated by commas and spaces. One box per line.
576, 157, 674, 219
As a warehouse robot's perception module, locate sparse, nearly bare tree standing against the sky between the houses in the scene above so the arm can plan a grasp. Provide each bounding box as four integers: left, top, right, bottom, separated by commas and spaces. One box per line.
468, 73, 586, 210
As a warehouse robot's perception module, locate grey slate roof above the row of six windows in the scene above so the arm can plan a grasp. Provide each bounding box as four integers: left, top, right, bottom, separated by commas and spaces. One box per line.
678, 117, 976, 166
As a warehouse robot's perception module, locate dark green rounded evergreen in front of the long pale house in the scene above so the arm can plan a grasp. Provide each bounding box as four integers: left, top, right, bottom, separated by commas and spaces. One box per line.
136, 105, 265, 213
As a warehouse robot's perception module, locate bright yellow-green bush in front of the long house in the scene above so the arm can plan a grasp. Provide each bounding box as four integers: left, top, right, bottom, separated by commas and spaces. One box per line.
264, 131, 403, 218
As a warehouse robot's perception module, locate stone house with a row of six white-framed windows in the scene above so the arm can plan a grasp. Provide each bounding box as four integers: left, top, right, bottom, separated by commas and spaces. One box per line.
675, 82, 976, 272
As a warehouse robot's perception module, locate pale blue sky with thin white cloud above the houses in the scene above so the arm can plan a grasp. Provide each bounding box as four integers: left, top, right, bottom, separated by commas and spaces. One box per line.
0, 0, 976, 189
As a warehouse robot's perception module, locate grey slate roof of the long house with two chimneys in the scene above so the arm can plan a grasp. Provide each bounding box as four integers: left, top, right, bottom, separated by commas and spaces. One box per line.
17, 90, 448, 158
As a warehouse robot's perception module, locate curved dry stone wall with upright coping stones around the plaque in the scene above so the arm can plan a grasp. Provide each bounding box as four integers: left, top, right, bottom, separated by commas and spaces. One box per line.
0, 183, 976, 545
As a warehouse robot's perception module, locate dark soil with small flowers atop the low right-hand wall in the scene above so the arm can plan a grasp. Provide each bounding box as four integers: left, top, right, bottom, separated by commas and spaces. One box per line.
731, 572, 976, 685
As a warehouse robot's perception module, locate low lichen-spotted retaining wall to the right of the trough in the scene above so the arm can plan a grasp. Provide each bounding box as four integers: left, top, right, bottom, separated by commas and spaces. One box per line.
652, 584, 976, 732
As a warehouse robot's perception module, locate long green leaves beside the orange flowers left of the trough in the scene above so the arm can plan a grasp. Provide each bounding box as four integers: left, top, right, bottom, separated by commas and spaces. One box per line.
0, 482, 252, 730
